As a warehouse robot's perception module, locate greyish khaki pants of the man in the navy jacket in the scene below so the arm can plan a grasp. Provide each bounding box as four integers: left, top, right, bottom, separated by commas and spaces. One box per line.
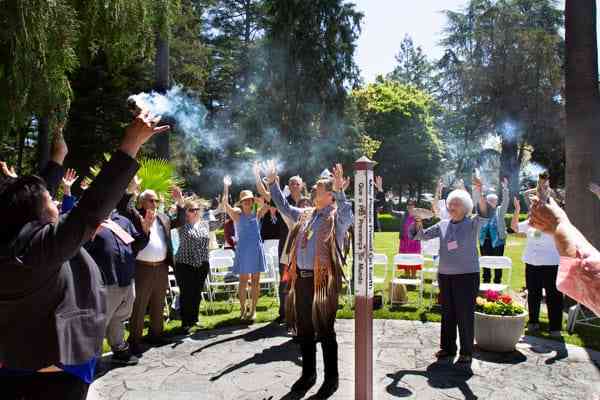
106, 282, 135, 352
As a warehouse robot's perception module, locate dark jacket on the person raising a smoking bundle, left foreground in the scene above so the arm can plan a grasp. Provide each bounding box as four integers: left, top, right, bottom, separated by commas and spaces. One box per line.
0, 152, 138, 370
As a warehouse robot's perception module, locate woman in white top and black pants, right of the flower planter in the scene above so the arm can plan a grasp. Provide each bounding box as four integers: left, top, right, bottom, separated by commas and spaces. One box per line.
511, 198, 563, 336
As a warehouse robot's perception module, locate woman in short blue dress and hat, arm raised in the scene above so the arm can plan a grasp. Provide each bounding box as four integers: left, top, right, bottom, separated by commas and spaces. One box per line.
223, 176, 266, 321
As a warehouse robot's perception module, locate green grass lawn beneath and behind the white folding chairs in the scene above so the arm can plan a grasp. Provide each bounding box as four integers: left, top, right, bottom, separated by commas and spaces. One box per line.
104, 232, 600, 351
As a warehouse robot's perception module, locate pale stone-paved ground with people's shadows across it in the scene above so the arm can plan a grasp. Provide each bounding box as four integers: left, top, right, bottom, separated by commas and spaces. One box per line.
88, 320, 600, 400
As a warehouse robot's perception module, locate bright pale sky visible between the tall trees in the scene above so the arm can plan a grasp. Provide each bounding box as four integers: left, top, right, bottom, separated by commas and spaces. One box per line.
349, 0, 600, 83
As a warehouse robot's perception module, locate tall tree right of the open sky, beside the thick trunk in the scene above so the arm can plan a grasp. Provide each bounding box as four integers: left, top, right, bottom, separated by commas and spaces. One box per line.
442, 0, 562, 191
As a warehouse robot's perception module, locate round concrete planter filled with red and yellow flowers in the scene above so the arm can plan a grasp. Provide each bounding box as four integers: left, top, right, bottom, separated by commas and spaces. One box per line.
475, 290, 527, 352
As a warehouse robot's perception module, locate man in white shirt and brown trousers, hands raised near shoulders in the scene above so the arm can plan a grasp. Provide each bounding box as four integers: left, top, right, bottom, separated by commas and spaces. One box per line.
129, 190, 177, 354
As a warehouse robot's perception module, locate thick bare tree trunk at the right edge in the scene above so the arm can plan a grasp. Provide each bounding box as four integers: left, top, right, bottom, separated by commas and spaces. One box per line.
565, 0, 600, 248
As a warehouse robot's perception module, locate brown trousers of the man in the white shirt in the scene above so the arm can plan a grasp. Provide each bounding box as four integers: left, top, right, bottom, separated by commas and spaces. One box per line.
129, 261, 169, 344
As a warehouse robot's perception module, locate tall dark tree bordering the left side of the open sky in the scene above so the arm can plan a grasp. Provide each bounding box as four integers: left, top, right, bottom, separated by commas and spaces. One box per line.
262, 0, 363, 142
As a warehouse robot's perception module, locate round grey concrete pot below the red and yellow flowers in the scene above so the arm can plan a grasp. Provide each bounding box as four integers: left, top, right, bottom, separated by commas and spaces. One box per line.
475, 311, 527, 352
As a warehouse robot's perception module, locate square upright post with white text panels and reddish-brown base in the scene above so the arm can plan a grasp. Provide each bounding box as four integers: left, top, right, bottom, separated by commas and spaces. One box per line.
354, 157, 375, 400
